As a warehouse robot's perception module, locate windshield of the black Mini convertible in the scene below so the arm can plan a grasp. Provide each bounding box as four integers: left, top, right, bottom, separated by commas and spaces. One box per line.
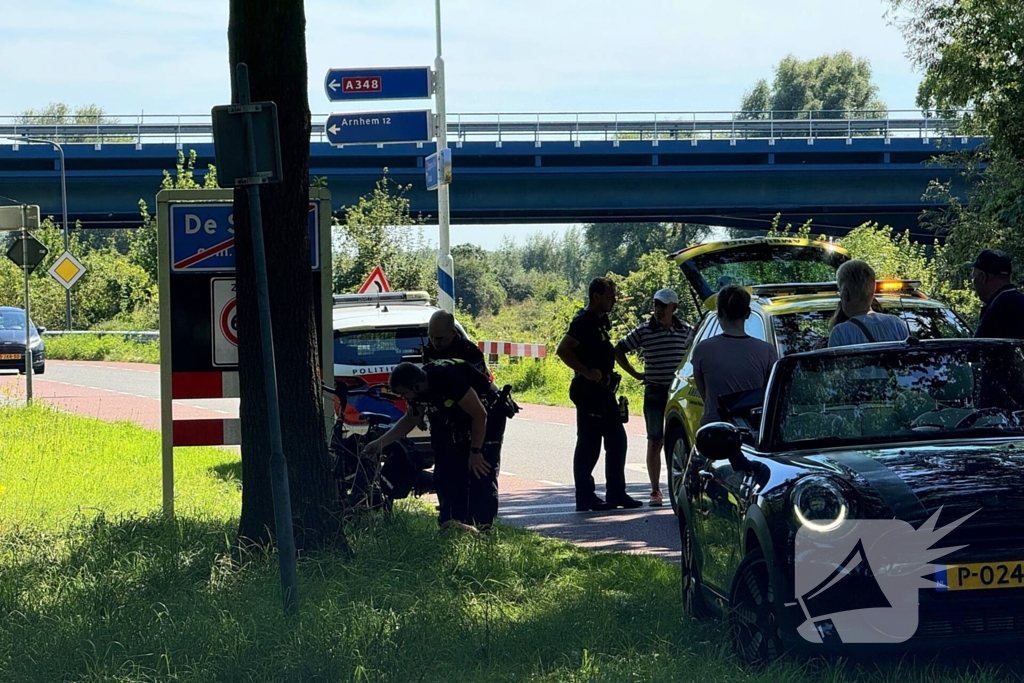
771, 342, 1024, 447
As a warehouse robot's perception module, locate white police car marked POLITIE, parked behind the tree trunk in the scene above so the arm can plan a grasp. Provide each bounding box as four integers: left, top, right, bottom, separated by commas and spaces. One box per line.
333, 291, 468, 447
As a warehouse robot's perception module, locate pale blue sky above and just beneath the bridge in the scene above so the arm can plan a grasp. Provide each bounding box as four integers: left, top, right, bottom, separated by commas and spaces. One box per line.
0, 0, 921, 248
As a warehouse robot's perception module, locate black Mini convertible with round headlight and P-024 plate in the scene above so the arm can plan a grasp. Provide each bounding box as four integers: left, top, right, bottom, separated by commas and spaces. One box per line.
676, 339, 1024, 661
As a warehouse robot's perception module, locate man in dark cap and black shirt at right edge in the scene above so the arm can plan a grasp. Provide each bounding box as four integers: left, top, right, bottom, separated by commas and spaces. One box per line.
973, 249, 1024, 339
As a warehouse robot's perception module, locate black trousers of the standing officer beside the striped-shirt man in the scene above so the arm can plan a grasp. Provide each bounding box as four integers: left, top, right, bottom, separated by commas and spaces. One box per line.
569, 380, 626, 505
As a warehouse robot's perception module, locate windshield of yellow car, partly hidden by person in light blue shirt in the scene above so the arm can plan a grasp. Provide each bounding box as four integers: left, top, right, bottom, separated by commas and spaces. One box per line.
771, 306, 972, 355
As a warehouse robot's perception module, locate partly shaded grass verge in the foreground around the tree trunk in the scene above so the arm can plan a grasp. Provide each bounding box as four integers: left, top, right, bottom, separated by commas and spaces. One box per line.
0, 407, 1024, 683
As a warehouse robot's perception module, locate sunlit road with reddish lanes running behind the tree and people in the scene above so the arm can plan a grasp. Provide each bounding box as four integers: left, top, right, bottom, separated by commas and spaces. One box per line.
6, 360, 679, 562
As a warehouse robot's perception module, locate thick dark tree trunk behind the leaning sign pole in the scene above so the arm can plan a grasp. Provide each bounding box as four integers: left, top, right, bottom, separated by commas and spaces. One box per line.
227, 0, 339, 550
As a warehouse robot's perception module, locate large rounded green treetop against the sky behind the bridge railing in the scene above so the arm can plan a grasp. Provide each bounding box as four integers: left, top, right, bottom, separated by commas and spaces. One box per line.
739, 50, 887, 119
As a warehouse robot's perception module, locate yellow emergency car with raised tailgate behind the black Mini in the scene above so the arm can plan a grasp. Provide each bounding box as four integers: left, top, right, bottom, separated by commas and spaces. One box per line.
665, 238, 972, 509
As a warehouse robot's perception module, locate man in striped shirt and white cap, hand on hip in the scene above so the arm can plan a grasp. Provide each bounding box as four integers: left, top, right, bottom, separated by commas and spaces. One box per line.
615, 289, 693, 507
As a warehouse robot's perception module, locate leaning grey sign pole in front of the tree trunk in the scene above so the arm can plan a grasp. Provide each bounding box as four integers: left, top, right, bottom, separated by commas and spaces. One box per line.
236, 62, 299, 614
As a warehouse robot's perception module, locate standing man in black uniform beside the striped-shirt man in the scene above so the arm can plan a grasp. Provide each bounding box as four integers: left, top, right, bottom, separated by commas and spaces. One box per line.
556, 278, 643, 512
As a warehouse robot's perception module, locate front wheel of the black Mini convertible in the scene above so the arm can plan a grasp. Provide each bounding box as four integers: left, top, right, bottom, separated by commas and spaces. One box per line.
729, 548, 783, 665
